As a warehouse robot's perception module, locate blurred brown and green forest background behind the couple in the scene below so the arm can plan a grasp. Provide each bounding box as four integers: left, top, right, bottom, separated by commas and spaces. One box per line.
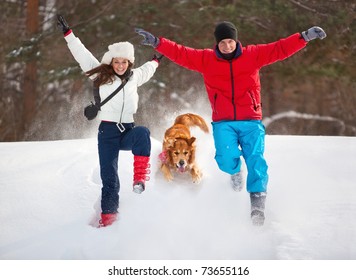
0, 0, 356, 142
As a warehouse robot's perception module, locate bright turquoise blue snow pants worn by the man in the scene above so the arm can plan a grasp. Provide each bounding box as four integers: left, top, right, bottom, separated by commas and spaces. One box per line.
212, 120, 268, 193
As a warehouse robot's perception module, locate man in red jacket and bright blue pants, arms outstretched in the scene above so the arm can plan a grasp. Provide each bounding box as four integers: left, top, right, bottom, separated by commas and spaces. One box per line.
136, 21, 326, 225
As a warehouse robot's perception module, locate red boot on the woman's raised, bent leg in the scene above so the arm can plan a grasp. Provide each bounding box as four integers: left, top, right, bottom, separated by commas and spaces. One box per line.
133, 156, 150, 193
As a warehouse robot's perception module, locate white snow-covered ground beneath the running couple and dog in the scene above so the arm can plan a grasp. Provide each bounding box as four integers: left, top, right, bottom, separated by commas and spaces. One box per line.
0, 130, 356, 279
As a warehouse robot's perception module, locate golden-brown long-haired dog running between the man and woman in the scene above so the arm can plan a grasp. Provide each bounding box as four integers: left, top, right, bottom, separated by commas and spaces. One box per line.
159, 114, 209, 183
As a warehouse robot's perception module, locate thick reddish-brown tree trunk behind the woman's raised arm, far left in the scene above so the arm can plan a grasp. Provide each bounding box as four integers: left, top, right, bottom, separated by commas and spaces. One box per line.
22, 0, 39, 139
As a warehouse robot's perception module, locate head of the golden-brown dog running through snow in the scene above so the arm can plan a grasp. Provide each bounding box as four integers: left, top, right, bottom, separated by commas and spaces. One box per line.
165, 137, 196, 173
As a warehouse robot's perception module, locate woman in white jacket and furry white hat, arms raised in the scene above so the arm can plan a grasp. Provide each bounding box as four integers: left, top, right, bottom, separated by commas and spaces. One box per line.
57, 15, 160, 226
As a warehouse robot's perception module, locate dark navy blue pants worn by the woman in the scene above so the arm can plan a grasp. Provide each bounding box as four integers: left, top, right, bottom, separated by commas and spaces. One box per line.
98, 122, 151, 214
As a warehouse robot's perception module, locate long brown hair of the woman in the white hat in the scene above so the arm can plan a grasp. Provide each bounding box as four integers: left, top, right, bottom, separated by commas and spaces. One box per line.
85, 61, 133, 87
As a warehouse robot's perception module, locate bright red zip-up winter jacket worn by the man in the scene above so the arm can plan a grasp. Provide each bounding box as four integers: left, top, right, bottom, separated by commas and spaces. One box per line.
156, 33, 307, 122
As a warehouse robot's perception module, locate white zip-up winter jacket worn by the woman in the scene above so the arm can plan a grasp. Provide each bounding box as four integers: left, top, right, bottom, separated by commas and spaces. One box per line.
64, 32, 158, 123
